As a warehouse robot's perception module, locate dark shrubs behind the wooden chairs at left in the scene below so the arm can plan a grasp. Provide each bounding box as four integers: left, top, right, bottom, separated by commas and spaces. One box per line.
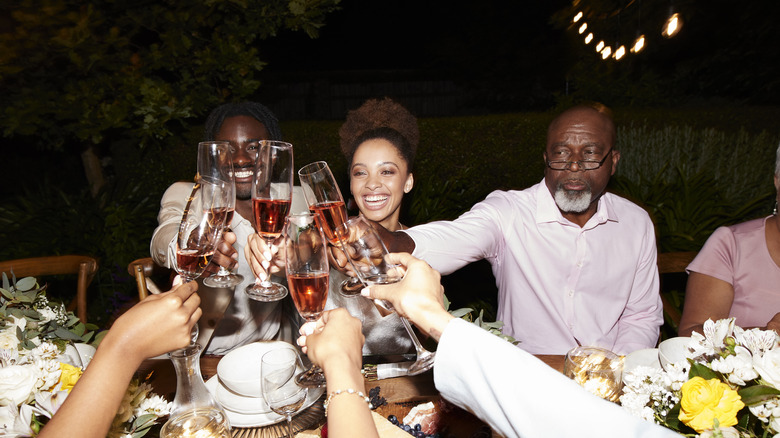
0, 180, 159, 323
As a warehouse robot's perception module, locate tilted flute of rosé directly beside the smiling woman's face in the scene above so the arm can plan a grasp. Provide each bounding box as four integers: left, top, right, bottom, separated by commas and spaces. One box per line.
298, 161, 363, 296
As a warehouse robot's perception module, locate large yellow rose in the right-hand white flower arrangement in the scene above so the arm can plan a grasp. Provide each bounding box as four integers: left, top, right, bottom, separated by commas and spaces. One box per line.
679, 376, 745, 433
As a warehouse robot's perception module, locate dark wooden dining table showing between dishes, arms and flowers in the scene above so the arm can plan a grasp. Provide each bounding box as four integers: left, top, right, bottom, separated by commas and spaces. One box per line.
138, 354, 564, 438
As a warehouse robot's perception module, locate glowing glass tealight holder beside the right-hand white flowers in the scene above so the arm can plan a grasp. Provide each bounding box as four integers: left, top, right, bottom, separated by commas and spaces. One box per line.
563, 347, 623, 402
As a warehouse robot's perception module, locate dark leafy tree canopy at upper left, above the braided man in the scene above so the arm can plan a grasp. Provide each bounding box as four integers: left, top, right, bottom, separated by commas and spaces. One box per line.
0, 0, 339, 152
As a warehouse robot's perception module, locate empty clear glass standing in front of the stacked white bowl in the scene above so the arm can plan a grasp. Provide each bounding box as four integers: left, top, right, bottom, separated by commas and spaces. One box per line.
260, 348, 308, 438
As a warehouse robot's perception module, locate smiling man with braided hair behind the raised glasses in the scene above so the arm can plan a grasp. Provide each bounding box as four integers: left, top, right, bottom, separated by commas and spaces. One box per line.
150, 102, 308, 354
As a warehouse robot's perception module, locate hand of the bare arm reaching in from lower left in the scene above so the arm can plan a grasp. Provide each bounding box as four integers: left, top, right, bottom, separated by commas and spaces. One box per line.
101, 281, 202, 362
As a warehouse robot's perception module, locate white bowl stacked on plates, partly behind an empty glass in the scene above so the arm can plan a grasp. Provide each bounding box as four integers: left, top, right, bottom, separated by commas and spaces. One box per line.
217, 341, 295, 397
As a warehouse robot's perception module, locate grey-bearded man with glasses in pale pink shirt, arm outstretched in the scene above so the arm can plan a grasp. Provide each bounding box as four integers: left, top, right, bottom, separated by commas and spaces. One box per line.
383, 105, 663, 354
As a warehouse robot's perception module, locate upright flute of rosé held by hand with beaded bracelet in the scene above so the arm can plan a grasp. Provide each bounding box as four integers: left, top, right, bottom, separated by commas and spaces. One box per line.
284, 213, 329, 387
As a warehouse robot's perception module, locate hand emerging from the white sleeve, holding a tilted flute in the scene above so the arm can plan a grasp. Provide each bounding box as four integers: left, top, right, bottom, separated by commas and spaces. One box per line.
361, 253, 452, 340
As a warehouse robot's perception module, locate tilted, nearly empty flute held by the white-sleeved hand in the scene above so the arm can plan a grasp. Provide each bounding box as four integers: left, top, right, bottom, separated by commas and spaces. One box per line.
338, 216, 436, 376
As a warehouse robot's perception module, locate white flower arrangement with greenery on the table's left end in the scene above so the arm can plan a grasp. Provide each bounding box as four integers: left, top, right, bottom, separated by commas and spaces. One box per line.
0, 273, 171, 438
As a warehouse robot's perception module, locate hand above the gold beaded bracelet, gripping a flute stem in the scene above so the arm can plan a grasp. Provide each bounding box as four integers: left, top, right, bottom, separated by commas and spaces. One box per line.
298, 308, 365, 372
